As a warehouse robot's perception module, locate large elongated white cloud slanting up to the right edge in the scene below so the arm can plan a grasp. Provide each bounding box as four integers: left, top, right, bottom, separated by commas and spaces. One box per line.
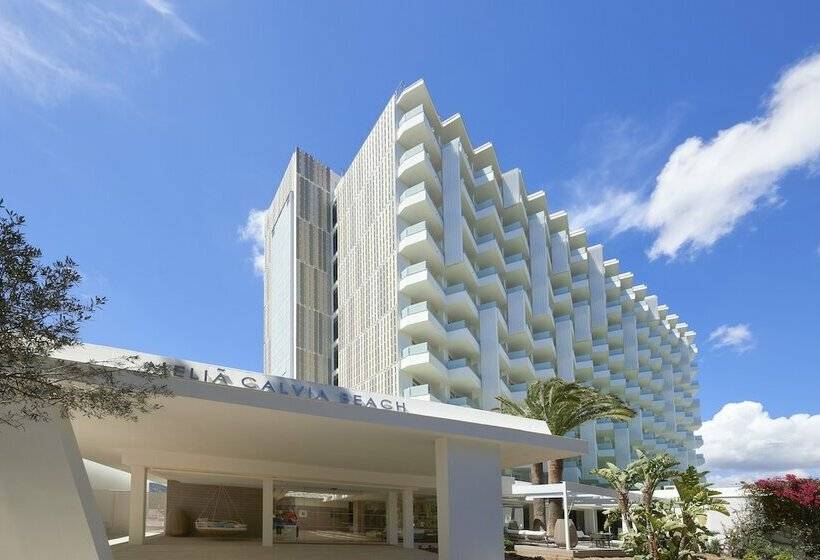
577, 53, 820, 259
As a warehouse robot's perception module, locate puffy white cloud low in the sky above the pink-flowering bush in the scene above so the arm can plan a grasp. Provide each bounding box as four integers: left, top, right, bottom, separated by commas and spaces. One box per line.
697, 401, 820, 483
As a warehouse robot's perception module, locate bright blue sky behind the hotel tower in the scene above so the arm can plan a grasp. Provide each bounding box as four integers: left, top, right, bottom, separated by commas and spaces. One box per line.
0, 0, 820, 482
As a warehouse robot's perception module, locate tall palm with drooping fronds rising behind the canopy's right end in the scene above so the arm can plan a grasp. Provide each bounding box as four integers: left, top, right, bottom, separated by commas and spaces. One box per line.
496, 378, 635, 534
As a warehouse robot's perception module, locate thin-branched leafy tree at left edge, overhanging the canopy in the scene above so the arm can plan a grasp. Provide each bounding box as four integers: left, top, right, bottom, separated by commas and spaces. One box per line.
0, 199, 170, 428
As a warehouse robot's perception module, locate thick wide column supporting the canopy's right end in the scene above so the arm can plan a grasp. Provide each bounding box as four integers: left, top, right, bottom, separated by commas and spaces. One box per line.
436, 438, 504, 560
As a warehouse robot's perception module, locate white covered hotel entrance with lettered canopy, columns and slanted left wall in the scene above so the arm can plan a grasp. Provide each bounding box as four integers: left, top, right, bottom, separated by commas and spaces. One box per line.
0, 345, 586, 560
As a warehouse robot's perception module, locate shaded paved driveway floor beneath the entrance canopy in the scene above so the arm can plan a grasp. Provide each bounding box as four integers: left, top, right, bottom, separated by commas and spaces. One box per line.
111, 535, 437, 560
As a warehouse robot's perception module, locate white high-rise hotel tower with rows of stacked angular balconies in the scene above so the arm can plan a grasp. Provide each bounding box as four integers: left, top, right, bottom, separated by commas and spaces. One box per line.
265, 81, 702, 483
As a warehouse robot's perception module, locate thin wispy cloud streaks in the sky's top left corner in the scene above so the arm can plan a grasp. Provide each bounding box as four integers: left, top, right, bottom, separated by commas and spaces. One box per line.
0, 0, 200, 105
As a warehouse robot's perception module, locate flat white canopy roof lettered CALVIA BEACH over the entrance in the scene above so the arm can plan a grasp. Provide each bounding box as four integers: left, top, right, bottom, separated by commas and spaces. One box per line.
65, 345, 586, 488
